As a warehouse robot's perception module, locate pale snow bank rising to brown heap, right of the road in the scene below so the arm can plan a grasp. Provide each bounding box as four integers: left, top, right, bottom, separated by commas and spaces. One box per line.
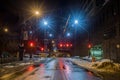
72, 59, 120, 72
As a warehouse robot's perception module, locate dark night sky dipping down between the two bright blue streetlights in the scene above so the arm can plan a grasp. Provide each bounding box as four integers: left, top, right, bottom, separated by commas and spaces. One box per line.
0, 0, 88, 39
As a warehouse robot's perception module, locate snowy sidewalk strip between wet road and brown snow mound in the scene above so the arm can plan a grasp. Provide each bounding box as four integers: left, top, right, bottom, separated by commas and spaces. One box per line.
70, 59, 120, 80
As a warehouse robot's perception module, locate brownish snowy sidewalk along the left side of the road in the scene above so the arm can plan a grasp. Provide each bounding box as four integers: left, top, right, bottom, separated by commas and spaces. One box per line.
0, 61, 32, 80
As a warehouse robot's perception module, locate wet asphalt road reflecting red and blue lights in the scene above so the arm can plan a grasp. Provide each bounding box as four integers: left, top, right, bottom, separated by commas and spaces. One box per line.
15, 58, 101, 80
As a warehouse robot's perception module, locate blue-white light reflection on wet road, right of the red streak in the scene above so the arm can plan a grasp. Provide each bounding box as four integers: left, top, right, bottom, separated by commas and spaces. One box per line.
64, 60, 101, 80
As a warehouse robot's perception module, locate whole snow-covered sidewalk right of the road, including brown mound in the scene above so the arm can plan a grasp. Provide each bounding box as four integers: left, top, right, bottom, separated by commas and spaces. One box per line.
70, 59, 120, 80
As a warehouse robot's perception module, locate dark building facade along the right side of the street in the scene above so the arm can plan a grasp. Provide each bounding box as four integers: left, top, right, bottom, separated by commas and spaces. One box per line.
91, 0, 120, 61
